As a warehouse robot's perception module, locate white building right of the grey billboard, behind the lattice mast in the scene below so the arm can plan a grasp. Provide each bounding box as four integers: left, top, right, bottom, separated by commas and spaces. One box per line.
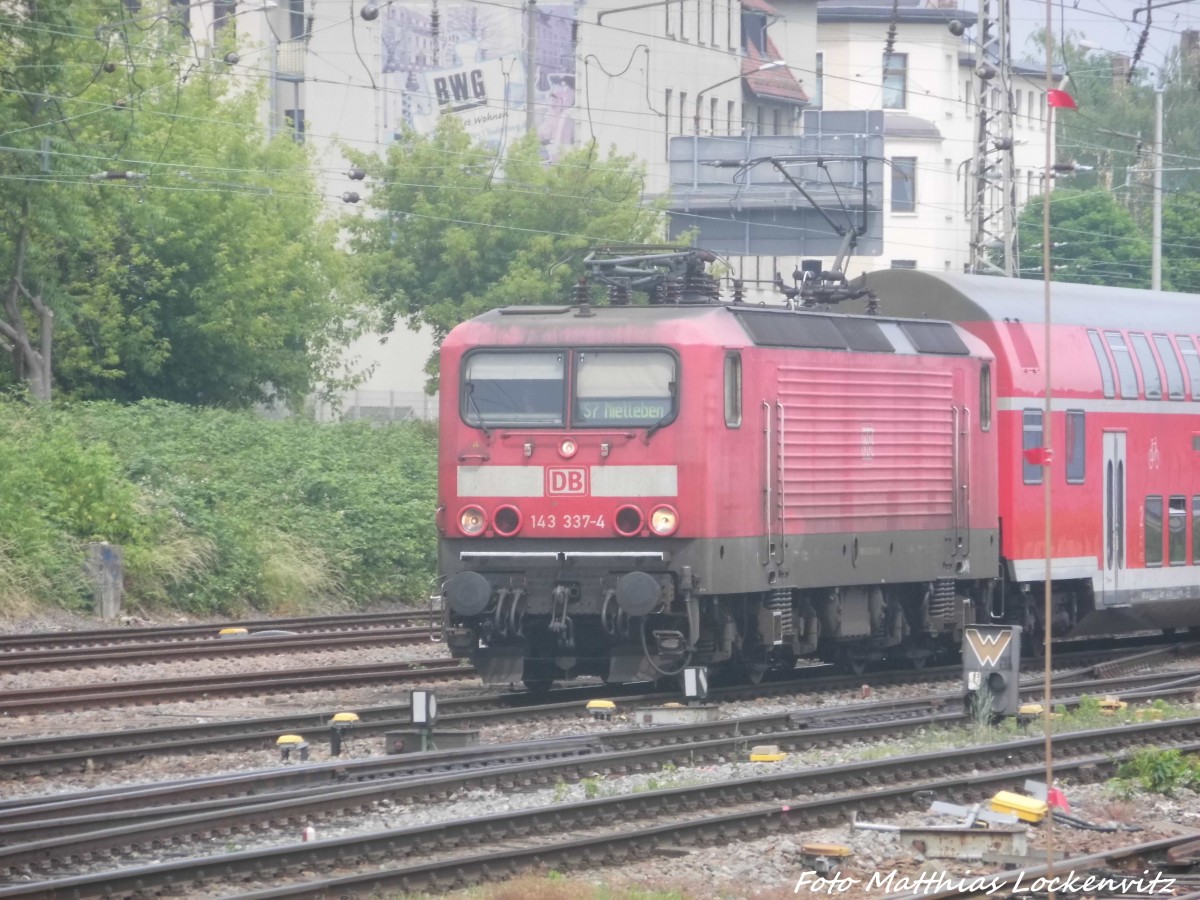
817, 0, 1052, 272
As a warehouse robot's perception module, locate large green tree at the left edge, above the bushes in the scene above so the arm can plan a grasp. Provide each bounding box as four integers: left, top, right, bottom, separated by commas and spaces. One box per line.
0, 0, 356, 406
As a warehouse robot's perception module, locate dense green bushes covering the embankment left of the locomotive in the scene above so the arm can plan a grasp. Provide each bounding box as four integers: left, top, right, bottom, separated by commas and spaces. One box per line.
0, 401, 436, 614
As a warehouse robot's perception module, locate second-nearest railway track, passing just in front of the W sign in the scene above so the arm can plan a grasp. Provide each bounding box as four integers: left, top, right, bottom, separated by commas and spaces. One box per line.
0, 676, 1200, 871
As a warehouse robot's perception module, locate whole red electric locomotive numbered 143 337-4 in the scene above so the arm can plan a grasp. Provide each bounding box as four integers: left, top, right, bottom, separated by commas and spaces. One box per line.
438, 254, 1003, 688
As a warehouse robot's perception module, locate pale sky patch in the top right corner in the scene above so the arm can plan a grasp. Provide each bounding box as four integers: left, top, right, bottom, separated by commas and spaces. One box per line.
1012, 0, 1200, 67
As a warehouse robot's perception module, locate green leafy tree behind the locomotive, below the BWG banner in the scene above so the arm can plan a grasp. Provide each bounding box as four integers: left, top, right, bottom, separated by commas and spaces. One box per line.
352, 116, 662, 384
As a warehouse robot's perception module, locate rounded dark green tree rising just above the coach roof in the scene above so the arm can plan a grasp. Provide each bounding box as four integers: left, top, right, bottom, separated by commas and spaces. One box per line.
1018, 188, 1150, 288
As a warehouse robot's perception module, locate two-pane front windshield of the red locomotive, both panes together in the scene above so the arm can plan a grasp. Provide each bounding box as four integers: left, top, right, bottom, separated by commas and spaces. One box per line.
460, 350, 678, 428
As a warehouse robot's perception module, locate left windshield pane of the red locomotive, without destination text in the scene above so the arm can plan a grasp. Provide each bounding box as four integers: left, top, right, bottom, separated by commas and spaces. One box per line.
461, 350, 565, 428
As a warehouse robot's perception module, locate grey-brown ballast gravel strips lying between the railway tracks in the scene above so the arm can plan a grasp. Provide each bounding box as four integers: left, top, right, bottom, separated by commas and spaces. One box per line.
0, 609, 1200, 900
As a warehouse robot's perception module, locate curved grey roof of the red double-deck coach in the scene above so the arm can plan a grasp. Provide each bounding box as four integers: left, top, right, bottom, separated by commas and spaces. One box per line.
866, 269, 1200, 332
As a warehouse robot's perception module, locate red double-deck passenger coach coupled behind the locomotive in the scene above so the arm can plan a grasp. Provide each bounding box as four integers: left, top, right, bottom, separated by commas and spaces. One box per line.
865, 270, 1200, 636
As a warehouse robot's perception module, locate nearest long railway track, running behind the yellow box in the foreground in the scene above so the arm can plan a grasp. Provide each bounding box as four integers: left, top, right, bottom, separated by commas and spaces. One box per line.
0, 719, 1200, 898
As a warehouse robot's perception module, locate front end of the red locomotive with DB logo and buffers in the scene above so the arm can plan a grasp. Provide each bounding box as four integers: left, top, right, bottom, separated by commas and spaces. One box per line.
442, 321, 686, 686
